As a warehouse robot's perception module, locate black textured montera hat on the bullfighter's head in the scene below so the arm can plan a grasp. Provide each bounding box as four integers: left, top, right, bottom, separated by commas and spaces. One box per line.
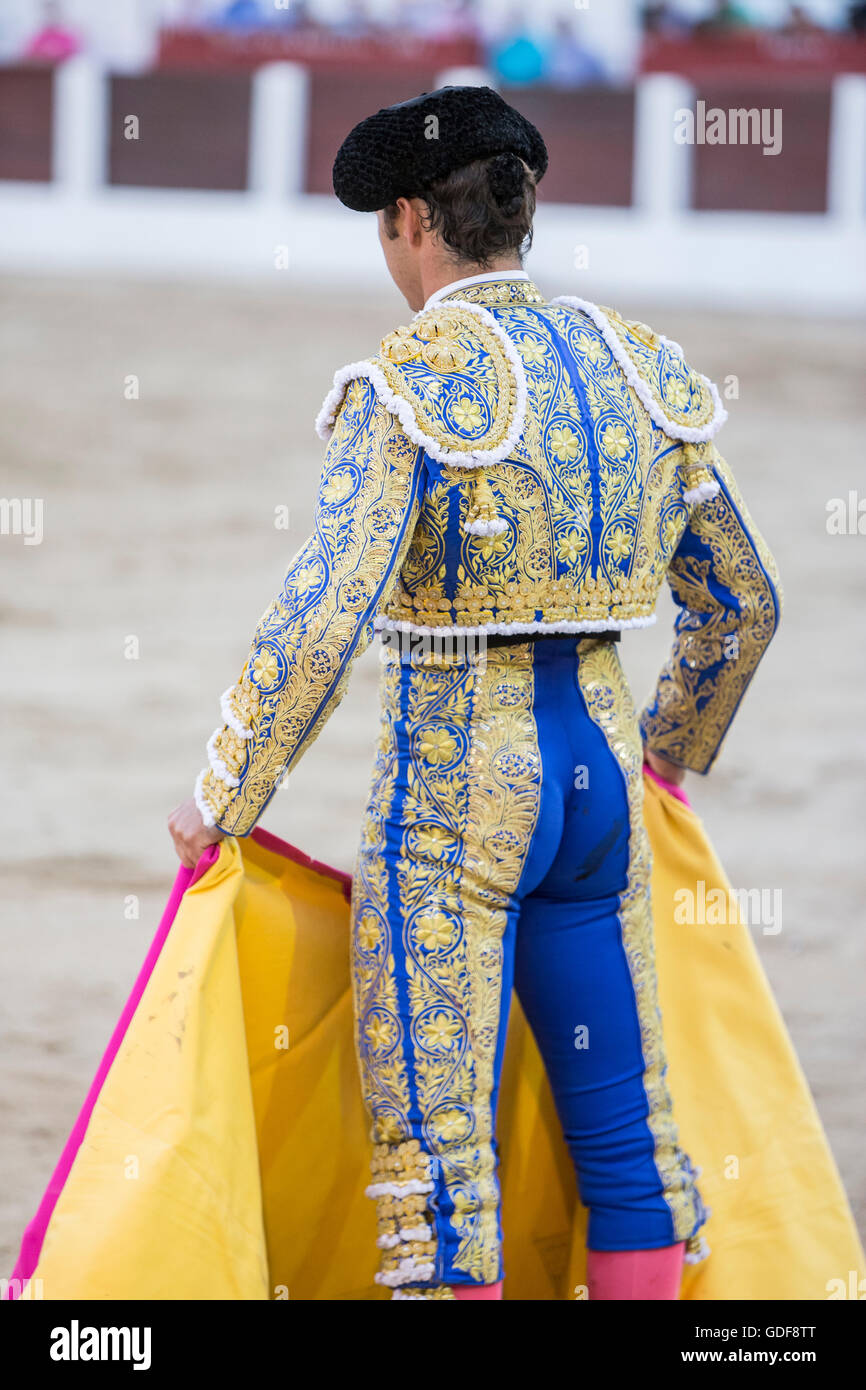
334, 86, 548, 213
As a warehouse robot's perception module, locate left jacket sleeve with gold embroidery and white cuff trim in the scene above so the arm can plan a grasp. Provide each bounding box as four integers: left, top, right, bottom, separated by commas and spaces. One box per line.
196, 378, 423, 835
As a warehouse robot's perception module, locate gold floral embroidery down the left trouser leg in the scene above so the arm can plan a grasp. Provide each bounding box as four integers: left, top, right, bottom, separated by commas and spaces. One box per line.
398, 648, 541, 1283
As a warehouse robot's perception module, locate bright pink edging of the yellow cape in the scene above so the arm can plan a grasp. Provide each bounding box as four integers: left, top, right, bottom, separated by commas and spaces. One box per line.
6, 763, 689, 1298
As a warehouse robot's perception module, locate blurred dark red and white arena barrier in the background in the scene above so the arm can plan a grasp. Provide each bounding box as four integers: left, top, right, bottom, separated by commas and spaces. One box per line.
0, 43, 866, 313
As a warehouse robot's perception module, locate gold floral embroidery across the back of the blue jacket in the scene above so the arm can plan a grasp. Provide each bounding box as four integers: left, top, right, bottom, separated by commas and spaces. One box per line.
382, 298, 667, 628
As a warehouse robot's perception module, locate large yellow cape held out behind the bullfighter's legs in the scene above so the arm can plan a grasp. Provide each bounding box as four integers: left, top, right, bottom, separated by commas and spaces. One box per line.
16, 781, 863, 1300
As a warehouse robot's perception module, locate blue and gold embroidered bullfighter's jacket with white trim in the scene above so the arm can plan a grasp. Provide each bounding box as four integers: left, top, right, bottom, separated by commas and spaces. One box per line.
196, 275, 781, 834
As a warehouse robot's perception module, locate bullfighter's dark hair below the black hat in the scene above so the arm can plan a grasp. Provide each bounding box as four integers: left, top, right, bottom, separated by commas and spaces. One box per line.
385, 154, 535, 267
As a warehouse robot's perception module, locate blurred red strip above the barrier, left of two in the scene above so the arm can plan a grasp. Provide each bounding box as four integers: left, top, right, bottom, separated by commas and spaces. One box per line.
157, 29, 482, 74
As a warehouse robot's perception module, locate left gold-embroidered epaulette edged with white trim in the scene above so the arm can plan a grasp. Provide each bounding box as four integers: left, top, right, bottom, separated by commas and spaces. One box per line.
316, 299, 527, 468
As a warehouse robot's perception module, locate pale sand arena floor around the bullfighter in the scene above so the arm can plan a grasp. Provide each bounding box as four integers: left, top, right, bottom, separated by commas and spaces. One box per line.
0, 273, 866, 1272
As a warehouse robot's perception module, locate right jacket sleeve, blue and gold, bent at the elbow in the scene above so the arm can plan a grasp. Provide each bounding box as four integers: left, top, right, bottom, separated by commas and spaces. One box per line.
641, 445, 783, 773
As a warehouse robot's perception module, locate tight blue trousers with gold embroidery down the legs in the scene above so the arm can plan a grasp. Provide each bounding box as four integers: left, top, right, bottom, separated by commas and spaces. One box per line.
353, 637, 706, 1298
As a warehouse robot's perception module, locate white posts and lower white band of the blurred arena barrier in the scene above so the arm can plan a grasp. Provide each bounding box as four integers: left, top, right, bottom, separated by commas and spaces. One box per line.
0, 57, 866, 313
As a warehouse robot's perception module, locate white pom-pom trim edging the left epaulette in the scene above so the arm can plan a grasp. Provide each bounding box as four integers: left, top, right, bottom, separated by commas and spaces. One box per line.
316, 299, 527, 468
